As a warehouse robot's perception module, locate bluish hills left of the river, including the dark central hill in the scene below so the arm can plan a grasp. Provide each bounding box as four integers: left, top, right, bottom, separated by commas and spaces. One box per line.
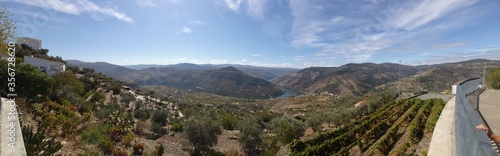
68, 60, 296, 97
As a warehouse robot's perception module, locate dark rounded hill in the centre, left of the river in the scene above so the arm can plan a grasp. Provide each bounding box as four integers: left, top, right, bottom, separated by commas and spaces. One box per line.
123, 67, 282, 97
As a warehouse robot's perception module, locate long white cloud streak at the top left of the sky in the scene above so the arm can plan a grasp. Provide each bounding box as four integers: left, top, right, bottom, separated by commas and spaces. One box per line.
13, 0, 134, 23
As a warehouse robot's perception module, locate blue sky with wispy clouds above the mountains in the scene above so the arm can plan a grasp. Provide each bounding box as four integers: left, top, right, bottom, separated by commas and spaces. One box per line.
6, 0, 500, 68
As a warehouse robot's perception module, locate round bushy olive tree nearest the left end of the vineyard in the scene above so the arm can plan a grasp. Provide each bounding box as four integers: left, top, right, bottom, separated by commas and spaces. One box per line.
270, 115, 305, 144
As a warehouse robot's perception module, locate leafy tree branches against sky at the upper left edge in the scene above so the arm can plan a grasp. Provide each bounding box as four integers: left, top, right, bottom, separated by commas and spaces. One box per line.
0, 3, 16, 54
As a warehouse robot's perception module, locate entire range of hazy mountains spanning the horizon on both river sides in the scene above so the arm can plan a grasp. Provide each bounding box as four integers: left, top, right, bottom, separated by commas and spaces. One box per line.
67, 59, 500, 97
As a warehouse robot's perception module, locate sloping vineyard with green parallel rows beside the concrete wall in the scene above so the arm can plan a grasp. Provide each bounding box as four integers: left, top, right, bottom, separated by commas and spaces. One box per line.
290, 99, 444, 156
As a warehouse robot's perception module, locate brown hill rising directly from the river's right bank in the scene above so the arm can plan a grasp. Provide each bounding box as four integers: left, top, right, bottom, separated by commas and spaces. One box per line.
273, 63, 417, 96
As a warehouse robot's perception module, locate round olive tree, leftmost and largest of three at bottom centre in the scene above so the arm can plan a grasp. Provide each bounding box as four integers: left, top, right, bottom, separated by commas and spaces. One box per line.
182, 112, 222, 154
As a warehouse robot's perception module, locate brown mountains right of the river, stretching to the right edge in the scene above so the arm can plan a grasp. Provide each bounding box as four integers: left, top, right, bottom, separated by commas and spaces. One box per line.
273, 59, 500, 96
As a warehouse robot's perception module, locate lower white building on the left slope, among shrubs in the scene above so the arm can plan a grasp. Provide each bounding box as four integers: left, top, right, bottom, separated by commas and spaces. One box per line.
24, 56, 66, 76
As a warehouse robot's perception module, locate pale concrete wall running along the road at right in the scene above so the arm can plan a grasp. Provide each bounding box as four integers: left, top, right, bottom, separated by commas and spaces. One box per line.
428, 79, 497, 156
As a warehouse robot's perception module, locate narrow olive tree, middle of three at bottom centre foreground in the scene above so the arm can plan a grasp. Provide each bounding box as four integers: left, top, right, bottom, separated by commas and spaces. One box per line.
238, 116, 263, 155
